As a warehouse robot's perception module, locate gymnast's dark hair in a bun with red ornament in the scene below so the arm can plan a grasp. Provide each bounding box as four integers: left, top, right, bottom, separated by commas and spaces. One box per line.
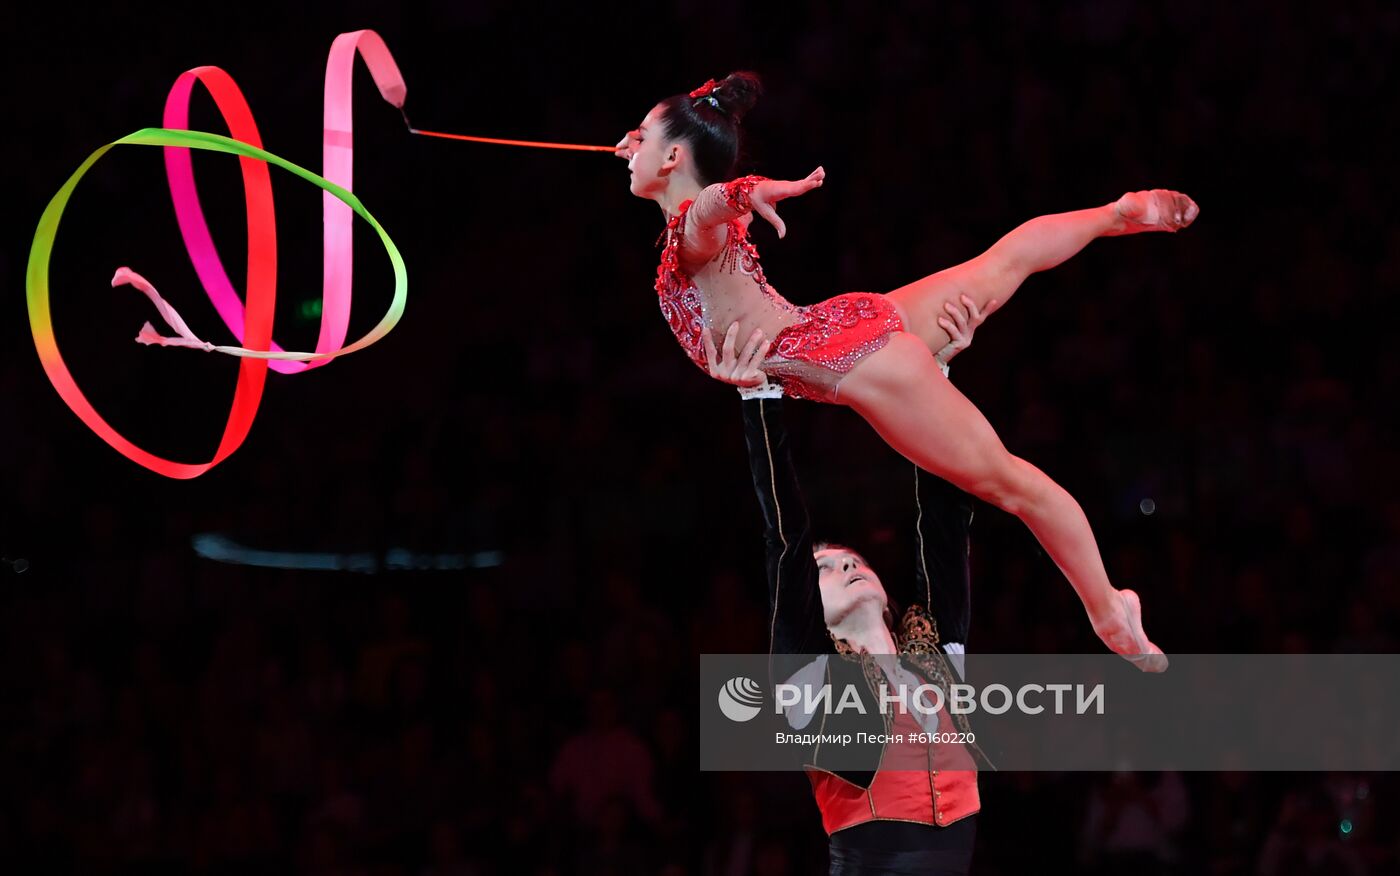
661, 70, 763, 185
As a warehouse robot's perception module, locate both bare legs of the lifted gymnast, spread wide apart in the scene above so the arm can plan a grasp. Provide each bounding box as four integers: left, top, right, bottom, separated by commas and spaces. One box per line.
839, 189, 1198, 672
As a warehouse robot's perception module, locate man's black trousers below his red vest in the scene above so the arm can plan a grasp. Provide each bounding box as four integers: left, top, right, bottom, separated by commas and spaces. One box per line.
830, 816, 977, 876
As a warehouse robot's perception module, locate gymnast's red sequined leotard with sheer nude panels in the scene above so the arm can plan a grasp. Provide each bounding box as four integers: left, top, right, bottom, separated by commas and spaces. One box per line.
657, 176, 904, 402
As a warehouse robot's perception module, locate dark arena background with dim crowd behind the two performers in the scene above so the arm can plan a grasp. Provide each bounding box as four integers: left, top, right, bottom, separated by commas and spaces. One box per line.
0, 0, 1400, 876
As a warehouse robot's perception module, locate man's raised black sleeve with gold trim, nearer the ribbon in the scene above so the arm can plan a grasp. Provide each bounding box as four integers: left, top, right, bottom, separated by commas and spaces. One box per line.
743, 399, 834, 654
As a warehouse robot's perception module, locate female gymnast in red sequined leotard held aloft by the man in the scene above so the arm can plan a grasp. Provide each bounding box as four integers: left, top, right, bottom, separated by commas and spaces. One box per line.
617, 73, 1198, 672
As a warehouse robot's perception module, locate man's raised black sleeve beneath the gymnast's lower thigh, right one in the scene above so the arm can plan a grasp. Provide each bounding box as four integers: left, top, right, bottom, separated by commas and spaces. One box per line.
896, 466, 972, 645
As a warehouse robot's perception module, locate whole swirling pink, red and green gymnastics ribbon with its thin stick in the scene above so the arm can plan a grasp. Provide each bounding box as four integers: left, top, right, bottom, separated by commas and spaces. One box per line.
25, 29, 615, 479
